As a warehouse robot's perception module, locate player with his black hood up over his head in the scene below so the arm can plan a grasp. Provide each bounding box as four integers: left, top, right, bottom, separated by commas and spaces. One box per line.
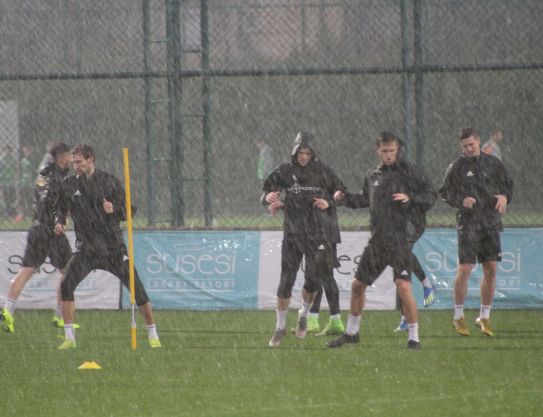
262, 132, 344, 347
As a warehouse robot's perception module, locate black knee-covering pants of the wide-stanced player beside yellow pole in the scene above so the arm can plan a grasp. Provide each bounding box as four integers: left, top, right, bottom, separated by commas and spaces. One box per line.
60, 252, 149, 306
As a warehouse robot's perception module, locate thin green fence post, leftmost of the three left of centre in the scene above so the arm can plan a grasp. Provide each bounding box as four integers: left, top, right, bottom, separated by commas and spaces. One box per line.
143, 0, 156, 226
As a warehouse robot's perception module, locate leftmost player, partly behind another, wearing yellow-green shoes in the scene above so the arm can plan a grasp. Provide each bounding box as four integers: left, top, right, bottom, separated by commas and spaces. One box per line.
0, 143, 78, 333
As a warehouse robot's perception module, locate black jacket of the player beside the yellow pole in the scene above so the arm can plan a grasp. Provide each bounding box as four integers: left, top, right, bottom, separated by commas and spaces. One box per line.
56, 170, 130, 255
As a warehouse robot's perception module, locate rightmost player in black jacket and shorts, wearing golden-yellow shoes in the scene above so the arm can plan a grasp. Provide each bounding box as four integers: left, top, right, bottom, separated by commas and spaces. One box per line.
439, 128, 513, 336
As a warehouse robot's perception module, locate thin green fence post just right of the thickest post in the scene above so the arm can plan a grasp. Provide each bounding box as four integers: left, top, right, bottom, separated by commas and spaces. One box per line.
200, 0, 213, 227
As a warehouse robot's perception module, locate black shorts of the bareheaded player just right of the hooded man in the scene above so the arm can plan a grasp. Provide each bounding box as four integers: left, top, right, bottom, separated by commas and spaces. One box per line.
354, 237, 413, 285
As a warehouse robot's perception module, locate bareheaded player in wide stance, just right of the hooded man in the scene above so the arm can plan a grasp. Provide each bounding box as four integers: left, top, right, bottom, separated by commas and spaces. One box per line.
327, 132, 437, 349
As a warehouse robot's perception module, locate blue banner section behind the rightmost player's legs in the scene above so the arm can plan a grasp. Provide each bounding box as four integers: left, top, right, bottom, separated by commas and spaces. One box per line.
413, 228, 543, 309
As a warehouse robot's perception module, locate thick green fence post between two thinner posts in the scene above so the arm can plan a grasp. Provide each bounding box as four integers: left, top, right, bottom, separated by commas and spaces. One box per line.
166, 0, 185, 227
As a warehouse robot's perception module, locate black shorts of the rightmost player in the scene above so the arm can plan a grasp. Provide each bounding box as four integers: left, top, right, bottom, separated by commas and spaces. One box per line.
458, 228, 502, 265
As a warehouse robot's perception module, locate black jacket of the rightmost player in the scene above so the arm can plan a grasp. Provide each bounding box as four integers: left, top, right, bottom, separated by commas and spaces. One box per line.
439, 153, 513, 230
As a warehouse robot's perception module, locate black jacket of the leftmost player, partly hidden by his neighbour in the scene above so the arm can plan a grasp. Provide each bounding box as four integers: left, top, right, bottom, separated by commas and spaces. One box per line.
33, 157, 69, 228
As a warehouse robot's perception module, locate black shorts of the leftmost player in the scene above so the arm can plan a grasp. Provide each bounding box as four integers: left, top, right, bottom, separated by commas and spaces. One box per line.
23, 225, 72, 269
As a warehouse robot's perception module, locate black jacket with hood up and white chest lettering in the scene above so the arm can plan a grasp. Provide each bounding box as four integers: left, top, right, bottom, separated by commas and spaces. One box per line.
261, 132, 345, 243
